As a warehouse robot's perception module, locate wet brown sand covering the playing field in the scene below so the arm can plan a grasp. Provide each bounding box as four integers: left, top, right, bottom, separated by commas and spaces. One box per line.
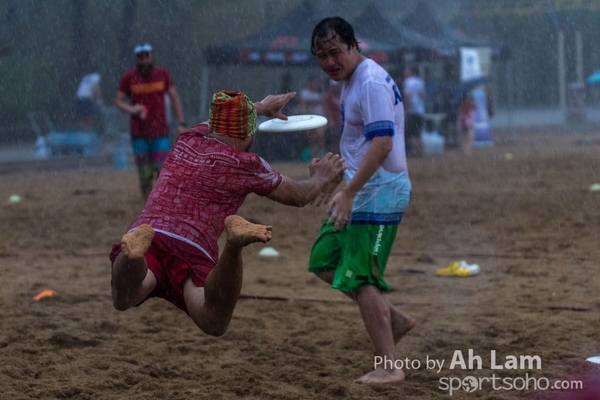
0, 134, 600, 400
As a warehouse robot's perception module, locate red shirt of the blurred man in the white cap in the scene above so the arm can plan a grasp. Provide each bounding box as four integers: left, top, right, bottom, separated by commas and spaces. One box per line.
119, 67, 173, 139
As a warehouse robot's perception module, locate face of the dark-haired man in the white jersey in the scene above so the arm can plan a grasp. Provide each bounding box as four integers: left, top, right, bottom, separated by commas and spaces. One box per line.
315, 32, 362, 81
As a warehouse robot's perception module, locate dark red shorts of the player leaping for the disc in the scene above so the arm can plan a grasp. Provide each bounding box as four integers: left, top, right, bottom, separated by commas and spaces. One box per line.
110, 232, 215, 313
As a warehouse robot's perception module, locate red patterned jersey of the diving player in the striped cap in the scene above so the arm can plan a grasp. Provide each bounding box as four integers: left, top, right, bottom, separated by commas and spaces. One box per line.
129, 124, 283, 261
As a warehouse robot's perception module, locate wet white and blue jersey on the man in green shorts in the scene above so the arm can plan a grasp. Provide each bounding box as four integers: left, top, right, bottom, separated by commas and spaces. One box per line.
340, 59, 411, 224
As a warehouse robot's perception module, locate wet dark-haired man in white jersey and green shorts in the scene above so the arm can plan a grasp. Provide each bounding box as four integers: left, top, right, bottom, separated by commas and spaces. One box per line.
308, 17, 415, 383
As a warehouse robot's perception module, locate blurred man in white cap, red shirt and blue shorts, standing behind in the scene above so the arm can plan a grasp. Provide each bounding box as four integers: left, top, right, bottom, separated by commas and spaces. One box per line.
115, 43, 186, 199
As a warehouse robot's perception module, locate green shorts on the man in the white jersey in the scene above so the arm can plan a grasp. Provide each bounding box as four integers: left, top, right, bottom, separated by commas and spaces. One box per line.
308, 223, 398, 292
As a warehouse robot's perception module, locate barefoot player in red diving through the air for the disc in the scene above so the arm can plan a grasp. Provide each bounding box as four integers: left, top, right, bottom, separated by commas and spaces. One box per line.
110, 91, 344, 336
